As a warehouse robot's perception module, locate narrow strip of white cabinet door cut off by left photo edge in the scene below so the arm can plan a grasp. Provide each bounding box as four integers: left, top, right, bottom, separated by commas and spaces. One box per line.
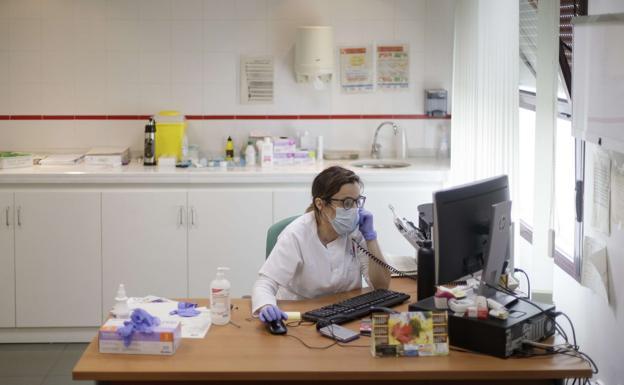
0, 192, 15, 328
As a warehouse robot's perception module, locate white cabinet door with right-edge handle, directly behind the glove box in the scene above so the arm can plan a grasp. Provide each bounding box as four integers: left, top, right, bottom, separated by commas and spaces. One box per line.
102, 190, 188, 316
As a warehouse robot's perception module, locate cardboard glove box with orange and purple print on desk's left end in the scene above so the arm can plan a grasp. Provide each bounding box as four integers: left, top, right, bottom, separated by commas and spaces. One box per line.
98, 319, 182, 356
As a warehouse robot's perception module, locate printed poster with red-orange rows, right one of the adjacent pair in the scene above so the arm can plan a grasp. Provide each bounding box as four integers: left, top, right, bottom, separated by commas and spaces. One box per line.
377, 44, 409, 89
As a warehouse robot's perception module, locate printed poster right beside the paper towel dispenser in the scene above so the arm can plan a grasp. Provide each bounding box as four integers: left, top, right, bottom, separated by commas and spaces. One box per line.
340, 47, 373, 93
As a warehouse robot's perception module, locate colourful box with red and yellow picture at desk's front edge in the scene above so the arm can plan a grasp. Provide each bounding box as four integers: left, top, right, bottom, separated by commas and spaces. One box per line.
371, 311, 449, 357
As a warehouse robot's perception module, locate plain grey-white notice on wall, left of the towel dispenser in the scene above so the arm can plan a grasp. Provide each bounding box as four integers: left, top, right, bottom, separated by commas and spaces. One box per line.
240, 56, 274, 104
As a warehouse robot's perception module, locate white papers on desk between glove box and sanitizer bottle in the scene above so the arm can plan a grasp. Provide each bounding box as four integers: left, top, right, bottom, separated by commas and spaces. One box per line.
128, 295, 211, 338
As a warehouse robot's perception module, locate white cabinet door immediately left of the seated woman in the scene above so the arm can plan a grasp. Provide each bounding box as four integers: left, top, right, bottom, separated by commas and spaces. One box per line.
188, 188, 272, 297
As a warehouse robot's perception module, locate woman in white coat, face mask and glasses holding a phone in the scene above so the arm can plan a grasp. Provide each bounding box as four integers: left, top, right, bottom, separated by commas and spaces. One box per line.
252, 166, 390, 322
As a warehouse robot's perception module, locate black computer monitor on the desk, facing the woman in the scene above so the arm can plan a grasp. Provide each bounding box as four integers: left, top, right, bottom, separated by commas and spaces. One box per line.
433, 175, 509, 285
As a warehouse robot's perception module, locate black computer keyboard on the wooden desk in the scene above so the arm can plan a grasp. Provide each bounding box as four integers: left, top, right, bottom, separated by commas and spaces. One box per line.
301, 289, 410, 324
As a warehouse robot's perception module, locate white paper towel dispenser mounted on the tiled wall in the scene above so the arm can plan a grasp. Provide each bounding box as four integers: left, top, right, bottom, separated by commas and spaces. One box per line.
295, 26, 334, 87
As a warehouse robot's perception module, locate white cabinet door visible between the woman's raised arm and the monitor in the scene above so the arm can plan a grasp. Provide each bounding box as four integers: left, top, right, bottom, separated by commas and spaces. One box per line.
363, 186, 440, 256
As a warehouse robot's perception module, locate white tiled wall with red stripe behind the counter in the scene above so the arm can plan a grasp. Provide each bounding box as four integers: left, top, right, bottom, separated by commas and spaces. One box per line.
0, 0, 454, 156
